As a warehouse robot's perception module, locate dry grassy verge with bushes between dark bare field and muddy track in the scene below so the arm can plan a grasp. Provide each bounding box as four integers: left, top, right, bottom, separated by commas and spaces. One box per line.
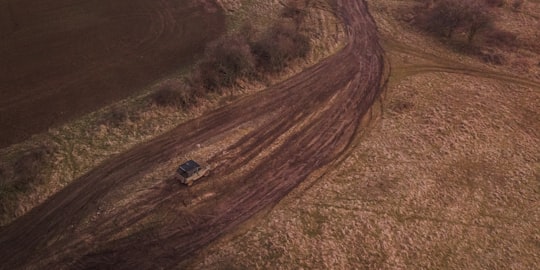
0, 0, 344, 226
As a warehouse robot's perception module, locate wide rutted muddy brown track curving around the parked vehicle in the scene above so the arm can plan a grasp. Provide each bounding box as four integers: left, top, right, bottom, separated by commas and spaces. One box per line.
0, 0, 387, 269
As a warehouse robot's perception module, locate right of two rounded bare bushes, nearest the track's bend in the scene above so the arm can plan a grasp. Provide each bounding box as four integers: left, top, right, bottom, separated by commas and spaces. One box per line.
252, 23, 311, 72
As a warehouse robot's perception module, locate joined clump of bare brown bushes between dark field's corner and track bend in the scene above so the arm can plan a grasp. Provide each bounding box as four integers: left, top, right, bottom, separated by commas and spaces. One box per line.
188, 0, 310, 93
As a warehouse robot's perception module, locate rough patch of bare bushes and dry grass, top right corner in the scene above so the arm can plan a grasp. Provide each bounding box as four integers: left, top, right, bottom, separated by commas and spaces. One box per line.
395, 0, 540, 72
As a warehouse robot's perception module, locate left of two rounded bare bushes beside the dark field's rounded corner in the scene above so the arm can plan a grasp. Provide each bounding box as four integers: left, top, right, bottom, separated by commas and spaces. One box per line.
193, 35, 255, 92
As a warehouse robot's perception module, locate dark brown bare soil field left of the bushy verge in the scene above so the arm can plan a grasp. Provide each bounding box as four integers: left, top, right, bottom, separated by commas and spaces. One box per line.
0, 0, 225, 147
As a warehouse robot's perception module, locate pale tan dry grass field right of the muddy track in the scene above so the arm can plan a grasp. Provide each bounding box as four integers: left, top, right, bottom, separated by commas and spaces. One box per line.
185, 0, 540, 269
